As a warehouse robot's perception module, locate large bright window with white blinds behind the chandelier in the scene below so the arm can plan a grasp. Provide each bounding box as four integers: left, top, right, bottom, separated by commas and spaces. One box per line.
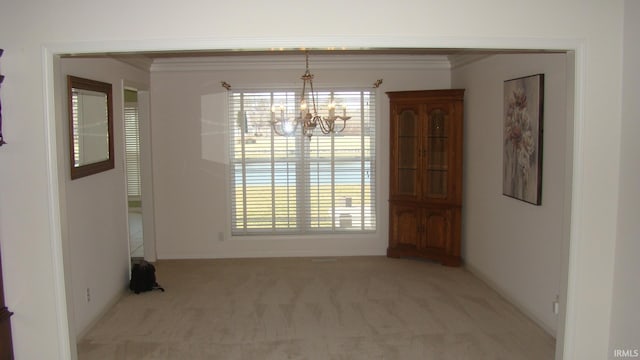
229, 89, 376, 235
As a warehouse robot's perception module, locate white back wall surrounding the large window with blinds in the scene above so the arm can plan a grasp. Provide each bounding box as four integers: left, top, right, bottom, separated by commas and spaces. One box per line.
151, 53, 450, 259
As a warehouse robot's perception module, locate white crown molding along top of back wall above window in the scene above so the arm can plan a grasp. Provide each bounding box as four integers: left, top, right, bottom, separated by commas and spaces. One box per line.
150, 54, 451, 72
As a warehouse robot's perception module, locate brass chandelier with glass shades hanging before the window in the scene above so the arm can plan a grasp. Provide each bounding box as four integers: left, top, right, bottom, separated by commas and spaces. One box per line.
271, 52, 351, 139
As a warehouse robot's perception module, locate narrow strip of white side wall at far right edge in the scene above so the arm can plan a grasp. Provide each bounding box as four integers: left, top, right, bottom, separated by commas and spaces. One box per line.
608, 1, 640, 359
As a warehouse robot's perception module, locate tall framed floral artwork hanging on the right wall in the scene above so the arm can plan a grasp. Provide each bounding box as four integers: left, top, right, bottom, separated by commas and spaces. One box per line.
502, 74, 544, 205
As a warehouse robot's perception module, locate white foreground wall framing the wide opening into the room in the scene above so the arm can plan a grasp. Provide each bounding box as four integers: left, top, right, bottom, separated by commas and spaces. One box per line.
0, 0, 638, 359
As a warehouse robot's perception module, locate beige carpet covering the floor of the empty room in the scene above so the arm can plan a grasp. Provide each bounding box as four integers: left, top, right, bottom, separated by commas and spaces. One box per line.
78, 257, 555, 360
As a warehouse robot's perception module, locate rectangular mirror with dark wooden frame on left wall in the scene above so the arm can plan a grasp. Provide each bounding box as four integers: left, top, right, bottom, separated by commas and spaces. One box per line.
67, 75, 114, 179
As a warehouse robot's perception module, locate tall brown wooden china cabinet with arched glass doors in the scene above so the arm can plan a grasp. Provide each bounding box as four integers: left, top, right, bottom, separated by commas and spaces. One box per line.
387, 89, 464, 266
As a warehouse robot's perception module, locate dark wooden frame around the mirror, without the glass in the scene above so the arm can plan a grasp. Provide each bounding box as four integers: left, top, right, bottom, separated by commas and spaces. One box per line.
67, 75, 115, 180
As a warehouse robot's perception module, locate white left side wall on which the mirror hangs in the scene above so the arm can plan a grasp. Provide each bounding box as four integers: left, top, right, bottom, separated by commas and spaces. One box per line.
56, 58, 149, 335
